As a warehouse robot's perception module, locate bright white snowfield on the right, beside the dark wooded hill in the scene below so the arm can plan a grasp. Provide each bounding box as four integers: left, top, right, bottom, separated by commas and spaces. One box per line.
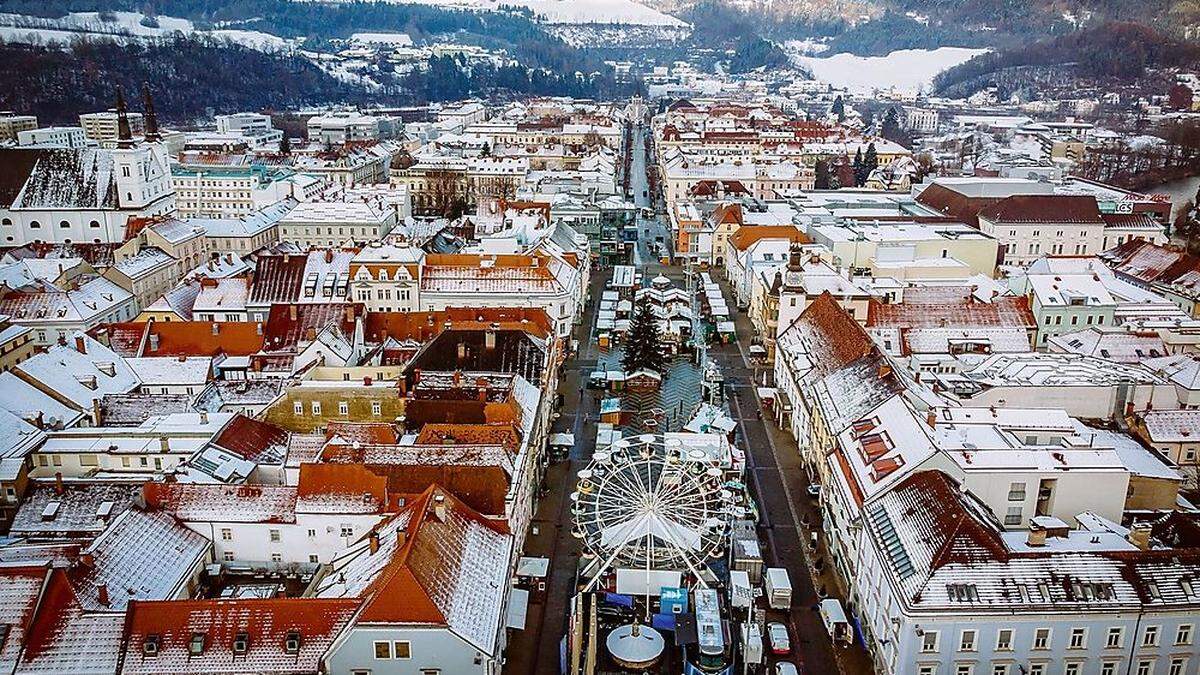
796, 47, 988, 94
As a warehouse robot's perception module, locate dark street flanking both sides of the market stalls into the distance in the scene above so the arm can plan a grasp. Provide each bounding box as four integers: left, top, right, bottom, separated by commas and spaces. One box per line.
504, 111, 871, 675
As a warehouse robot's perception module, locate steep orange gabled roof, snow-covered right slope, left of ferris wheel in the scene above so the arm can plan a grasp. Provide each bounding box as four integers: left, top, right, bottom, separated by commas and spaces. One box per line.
317, 486, 512, 656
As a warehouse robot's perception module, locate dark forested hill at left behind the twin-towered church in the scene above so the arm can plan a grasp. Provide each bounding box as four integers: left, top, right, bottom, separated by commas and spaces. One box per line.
0, 40, 362, 124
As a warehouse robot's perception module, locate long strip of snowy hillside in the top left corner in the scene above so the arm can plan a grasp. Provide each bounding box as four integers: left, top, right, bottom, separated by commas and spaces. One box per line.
0, 12, 287, 50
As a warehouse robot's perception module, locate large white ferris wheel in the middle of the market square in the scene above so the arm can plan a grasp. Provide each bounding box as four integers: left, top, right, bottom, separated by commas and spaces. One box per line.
571, 434, 740, 578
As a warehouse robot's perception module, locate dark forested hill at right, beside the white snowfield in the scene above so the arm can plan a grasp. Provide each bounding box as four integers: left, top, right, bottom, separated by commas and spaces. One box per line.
934, 22, 1200, 96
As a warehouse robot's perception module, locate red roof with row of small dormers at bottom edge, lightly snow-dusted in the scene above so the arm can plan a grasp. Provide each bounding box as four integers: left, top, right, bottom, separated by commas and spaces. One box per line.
120, 598, 359, 675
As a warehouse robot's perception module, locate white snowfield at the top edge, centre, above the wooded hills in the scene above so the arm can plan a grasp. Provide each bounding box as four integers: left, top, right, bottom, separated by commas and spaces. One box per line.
321, 0, 688, 26
